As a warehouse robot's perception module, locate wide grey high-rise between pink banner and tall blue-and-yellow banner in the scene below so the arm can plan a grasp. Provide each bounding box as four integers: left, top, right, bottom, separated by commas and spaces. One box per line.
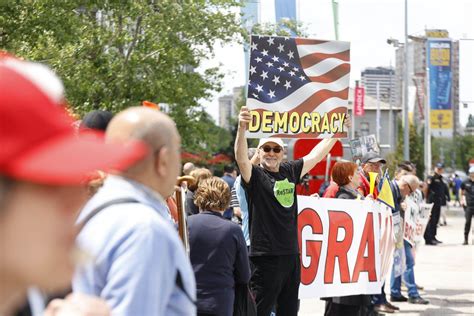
361, 67, 397, 104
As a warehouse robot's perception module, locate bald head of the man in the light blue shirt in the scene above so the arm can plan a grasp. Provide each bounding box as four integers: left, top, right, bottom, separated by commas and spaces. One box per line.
106, 107, 181, 197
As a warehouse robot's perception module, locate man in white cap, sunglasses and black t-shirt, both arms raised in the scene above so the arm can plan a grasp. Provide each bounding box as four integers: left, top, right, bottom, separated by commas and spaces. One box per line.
235, 107, 348, 316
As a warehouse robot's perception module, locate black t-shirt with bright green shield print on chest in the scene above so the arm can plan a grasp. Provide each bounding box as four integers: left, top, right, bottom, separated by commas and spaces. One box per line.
242, 159, 303, 256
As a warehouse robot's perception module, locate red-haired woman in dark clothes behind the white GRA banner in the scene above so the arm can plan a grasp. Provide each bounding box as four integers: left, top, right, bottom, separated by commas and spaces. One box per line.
324, 161, 375, 316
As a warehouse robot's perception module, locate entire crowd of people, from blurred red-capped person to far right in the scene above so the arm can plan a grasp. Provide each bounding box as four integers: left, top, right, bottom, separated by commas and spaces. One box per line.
0, 54, 474, 316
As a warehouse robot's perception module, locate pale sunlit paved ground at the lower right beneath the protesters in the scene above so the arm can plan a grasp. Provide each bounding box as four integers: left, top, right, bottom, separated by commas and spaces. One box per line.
298, 208, 474, 316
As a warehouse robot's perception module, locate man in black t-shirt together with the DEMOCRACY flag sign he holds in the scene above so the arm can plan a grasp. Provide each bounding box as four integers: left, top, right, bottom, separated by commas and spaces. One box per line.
235, 36, 350, 316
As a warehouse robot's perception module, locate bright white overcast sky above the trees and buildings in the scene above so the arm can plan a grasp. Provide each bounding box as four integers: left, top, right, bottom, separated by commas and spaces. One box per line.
204, 0, 474, 123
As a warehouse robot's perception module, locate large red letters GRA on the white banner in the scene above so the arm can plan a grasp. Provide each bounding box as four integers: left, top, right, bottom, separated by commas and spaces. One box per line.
298, 208, 377, 285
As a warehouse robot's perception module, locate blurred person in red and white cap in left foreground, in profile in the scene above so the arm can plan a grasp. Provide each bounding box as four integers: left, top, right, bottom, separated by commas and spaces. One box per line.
0, 52, 146, 315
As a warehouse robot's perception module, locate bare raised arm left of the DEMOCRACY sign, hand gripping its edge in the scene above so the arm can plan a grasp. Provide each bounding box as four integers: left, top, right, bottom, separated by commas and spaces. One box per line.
234, 106, 252, 183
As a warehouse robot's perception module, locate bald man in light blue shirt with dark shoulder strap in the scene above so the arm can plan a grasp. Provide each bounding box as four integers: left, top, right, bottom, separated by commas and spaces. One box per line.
73, 107, 196, 316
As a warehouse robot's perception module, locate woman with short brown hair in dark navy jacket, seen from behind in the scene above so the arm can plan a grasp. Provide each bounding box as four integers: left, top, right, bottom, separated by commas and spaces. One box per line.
188, 177, 250, 316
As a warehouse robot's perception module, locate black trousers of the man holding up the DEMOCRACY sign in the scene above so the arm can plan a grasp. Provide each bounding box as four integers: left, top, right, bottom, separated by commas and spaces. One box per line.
250, 254, 301, 316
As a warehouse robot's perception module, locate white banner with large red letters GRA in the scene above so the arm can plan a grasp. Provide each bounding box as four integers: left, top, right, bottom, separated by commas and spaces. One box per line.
298, 196, 394, 298
